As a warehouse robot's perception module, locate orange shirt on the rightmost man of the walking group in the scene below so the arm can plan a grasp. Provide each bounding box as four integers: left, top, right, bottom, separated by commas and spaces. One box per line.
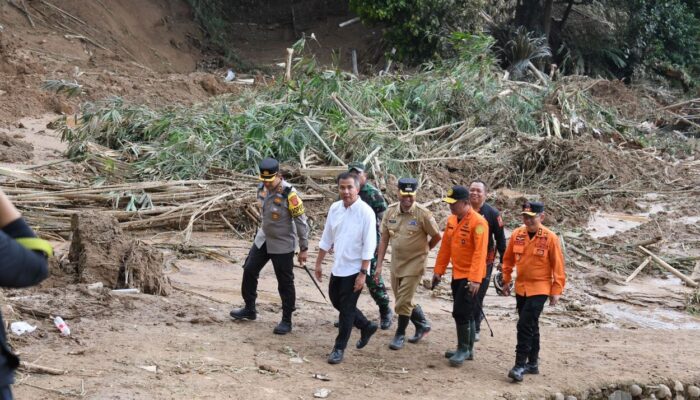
503, 226, 566, 296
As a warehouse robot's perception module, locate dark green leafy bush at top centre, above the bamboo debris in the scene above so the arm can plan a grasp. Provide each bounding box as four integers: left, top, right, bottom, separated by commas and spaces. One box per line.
350, 0, 486, 62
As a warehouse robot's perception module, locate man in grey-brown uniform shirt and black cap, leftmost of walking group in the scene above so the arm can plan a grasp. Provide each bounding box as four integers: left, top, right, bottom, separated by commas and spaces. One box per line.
230, 158, 309, 335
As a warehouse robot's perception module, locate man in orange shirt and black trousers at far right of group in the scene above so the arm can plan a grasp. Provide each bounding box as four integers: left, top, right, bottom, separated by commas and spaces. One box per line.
502, 202, 566, 382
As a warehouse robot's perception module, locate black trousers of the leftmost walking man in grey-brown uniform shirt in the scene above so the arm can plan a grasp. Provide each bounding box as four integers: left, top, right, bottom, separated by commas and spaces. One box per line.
241, 244, 296, 318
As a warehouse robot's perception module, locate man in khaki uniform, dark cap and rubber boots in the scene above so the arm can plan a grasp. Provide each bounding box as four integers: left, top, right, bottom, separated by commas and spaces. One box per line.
375, 178, 441, 350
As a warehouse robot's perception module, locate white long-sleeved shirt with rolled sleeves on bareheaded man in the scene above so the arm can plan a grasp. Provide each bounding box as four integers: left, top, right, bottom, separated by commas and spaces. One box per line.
318, 198, 377, 276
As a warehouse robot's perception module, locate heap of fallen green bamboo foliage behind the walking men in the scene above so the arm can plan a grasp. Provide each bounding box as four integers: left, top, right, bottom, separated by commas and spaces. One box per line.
62, 34, 538, 179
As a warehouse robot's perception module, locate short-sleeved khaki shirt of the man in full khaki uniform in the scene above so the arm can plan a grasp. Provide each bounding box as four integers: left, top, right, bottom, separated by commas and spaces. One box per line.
381, 203, 440, 277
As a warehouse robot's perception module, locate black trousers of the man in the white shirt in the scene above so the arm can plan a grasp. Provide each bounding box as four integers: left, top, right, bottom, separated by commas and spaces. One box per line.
328, 274, 369, 350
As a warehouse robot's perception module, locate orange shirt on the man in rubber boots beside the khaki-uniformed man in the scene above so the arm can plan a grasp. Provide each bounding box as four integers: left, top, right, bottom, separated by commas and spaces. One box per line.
435, 208, 489, 282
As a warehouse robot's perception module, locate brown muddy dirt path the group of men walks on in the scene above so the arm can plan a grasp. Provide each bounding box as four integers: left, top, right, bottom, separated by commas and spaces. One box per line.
8, 235, 700, 399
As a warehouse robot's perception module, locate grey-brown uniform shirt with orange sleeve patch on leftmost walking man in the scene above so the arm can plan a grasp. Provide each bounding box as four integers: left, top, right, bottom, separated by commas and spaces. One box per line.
255, 181, 309, 254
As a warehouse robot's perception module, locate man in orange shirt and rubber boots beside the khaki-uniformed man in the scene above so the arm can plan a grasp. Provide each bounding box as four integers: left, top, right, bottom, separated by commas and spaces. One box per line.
433, 186, 489, 367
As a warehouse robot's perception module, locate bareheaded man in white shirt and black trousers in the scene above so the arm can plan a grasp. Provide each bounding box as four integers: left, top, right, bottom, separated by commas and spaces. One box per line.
315, 172, 377, 364
